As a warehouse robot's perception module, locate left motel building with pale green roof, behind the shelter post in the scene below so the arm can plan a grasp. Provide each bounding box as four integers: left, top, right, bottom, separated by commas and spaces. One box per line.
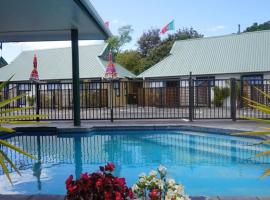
0, 43, 135, 109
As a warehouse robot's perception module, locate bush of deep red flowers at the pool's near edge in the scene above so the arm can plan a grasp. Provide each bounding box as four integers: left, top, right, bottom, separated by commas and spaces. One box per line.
66, 163, 133, 200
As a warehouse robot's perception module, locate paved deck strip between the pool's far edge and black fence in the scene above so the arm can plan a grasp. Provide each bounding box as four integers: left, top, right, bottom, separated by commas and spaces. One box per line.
4, 119, 270, 131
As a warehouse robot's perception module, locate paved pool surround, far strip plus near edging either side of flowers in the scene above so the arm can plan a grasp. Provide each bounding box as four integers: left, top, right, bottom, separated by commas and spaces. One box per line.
0, 119, 270, 200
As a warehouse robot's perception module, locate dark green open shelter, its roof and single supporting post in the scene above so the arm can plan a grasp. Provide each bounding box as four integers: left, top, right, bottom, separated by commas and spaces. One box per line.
0, 0, 111, 126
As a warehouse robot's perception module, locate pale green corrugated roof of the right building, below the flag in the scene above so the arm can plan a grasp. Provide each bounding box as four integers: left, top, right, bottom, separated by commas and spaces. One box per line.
138, 31, 270, 78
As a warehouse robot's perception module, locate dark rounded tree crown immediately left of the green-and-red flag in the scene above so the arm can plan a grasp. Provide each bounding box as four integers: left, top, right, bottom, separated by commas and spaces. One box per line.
137, 29, 161, 56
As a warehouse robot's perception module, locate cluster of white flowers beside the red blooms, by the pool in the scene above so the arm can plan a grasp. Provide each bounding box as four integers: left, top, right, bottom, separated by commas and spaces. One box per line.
132, 166, 189, 200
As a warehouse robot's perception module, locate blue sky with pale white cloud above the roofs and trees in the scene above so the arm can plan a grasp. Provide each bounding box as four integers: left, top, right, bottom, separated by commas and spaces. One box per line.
0, 0, 270, 63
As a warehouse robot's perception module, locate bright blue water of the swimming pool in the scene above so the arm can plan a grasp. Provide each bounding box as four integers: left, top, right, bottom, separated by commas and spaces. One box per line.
0, 130, 270, 196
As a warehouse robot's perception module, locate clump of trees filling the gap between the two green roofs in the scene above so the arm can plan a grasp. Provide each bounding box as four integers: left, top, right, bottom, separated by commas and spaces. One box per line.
116, 28, 203, 75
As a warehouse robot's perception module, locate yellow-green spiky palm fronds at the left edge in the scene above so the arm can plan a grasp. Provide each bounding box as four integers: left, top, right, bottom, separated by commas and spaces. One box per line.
0, 76, 46, 183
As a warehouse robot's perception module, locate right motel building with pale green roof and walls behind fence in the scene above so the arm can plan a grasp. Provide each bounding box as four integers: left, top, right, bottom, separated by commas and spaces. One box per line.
137, 31, 270, 107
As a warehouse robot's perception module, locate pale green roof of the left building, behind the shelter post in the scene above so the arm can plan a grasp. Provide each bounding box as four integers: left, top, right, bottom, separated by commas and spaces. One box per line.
0, 44, 135, 81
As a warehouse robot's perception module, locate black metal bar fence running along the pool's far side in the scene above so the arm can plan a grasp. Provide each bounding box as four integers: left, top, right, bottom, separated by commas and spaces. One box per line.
0, 78, 270, 121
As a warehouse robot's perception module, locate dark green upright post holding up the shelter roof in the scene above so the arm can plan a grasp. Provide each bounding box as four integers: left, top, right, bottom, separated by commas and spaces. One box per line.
71, 29, 81, 126
